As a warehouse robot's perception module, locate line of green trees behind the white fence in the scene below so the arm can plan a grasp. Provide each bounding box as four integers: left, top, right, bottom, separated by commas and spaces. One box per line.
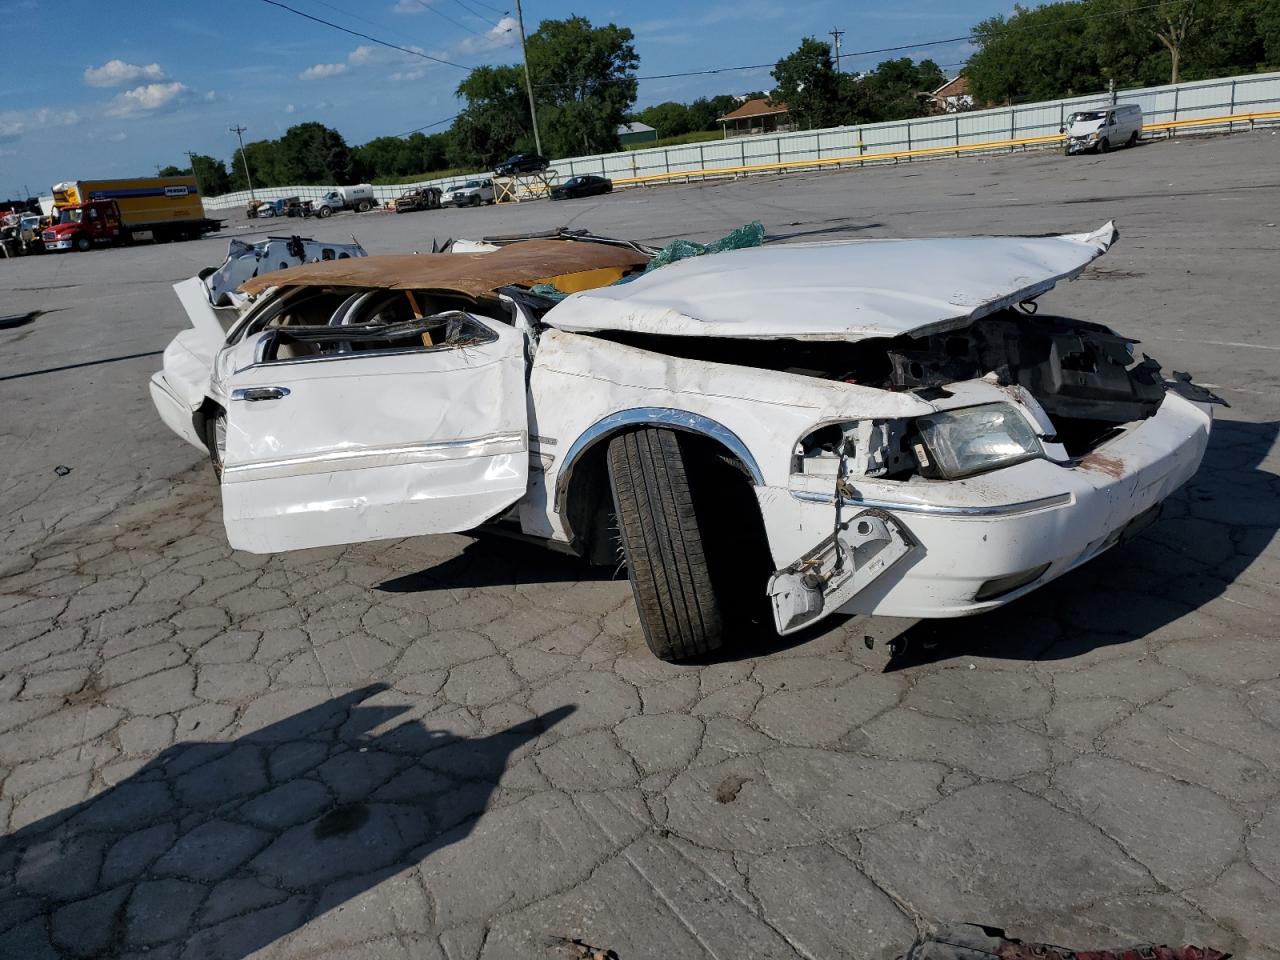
161, 0, 1280, 196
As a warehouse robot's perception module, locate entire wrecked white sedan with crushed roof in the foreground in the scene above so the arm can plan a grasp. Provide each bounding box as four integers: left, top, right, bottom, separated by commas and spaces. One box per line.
152, 224, 1216, 659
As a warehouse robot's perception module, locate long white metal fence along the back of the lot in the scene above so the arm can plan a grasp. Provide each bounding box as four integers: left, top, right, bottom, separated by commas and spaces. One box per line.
205, 73, 1280, 210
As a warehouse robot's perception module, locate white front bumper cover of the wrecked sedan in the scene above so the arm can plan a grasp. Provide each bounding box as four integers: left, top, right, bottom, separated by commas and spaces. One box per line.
759, 393, 1212, 617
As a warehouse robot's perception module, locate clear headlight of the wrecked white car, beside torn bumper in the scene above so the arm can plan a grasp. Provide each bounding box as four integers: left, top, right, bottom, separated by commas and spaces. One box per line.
915, 403, 1043, 480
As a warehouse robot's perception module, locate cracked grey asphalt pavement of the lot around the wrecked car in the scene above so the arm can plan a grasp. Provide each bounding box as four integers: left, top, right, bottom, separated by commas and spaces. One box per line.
0, 132, 1280, 960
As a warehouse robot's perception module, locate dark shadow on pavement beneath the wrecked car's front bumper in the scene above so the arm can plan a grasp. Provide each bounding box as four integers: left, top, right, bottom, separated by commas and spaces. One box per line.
886, 420, 1280, 672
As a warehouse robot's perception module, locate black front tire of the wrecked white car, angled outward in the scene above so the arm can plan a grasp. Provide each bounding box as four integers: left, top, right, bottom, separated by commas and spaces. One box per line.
608, 428, 724, 660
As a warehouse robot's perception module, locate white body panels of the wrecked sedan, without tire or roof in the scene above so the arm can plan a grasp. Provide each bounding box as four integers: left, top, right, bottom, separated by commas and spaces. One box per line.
147, 224, 1212, 632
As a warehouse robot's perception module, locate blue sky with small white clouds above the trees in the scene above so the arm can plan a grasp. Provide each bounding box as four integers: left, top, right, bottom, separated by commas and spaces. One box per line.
0, 0, 988, 197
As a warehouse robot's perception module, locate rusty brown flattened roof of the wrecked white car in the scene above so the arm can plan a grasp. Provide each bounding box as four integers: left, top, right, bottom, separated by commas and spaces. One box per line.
241, 239, 649, 298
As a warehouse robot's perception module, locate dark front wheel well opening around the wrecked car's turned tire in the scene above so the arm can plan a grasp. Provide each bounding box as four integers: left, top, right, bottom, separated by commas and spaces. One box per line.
561, 424, 767, 564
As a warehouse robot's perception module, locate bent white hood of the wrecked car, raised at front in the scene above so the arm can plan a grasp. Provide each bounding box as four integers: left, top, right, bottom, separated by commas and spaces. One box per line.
544, 221, 1119, 340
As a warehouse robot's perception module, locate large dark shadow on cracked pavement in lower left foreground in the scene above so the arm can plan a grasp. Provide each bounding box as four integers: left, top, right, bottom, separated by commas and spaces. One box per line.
0, 685, 573, 960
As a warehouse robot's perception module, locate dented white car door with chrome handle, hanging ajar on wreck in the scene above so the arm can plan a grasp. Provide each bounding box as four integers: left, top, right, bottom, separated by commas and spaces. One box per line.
221, 314, 529, 553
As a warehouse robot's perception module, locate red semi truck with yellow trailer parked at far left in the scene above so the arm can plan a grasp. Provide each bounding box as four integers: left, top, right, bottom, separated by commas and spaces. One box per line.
41, 177, 221, 251
